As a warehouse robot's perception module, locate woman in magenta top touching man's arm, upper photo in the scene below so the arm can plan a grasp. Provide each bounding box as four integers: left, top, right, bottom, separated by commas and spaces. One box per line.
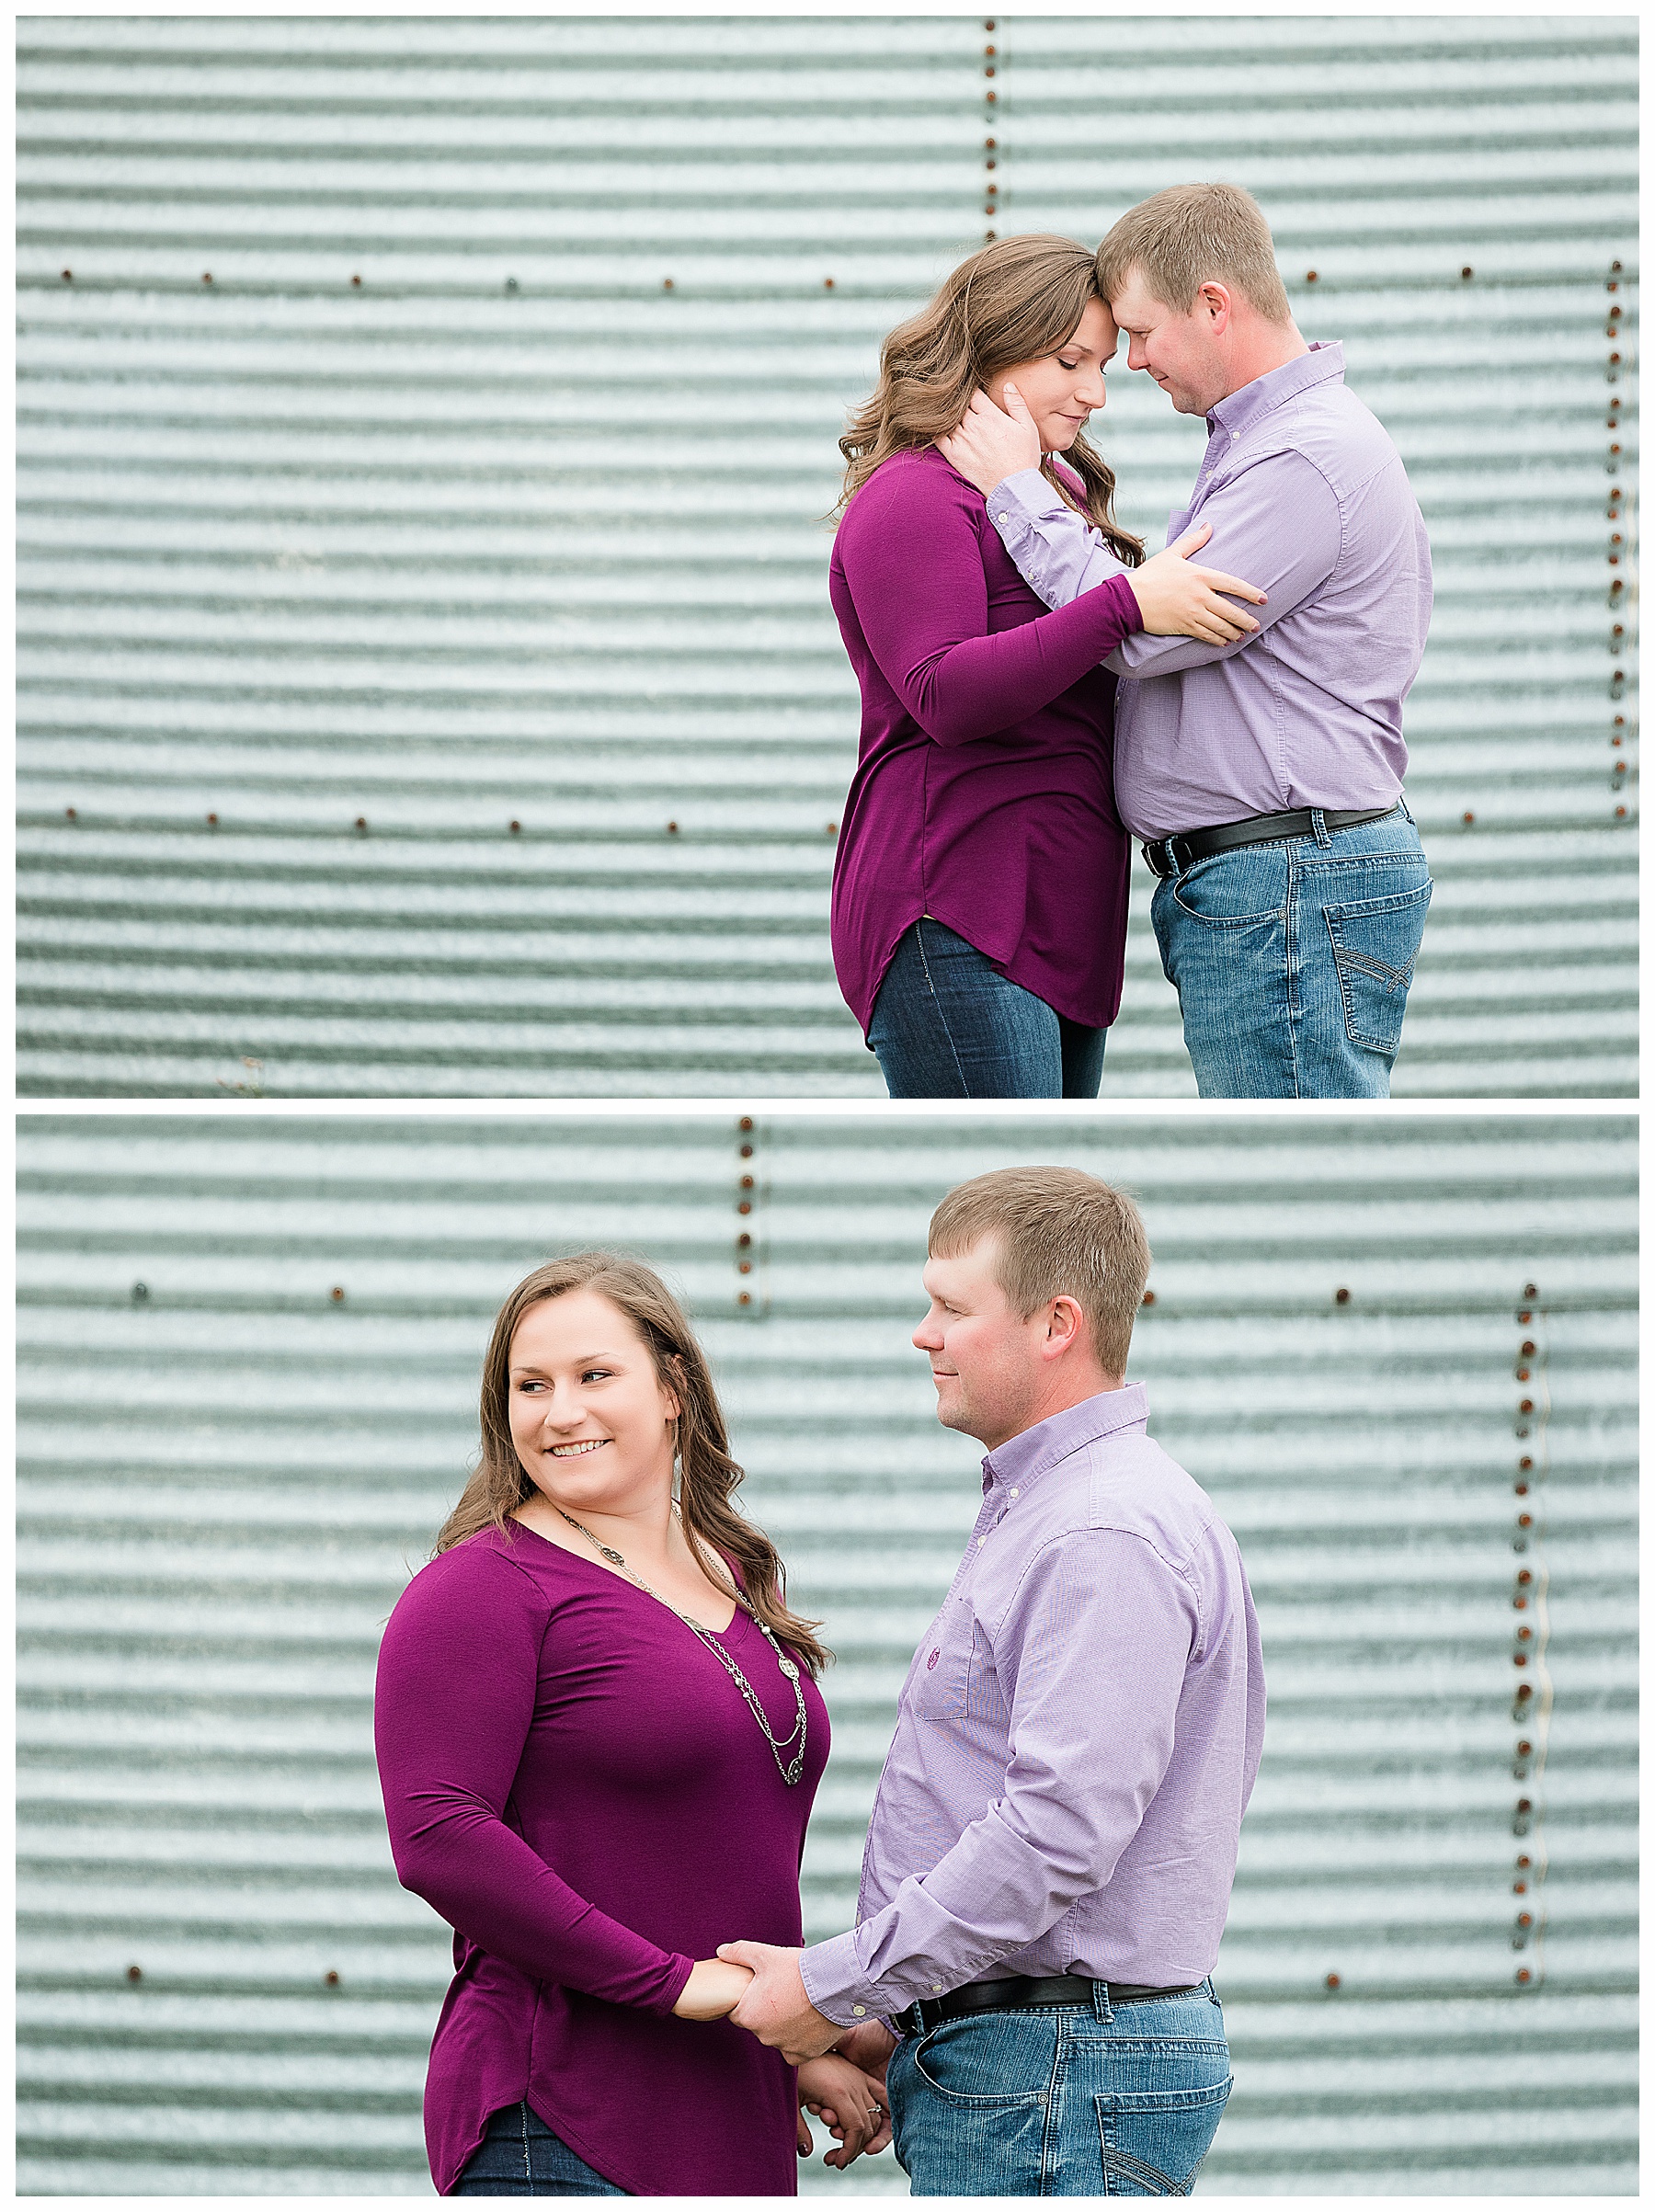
829, 236, 1261, 1097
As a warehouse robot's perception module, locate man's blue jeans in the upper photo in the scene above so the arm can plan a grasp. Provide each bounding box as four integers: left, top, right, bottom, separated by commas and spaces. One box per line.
1150, 805, 1432, 1100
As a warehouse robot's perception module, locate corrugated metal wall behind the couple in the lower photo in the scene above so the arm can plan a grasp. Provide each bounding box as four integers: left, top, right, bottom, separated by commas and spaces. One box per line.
20, 1112, 1635, 2195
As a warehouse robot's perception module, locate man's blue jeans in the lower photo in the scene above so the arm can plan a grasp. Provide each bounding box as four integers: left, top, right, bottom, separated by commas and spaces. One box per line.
885, 1982, 1230, 2196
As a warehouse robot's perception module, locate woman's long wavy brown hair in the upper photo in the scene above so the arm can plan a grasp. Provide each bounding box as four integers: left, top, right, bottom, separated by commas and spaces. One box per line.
839, 233, 1144, 568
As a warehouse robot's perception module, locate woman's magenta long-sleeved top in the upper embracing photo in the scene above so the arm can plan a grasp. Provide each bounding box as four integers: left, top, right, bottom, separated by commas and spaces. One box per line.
829, 447, 1142, 1033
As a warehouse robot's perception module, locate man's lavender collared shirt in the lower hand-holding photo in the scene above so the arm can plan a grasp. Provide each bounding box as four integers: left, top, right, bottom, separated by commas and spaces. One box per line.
801, 1385, 1263, 2026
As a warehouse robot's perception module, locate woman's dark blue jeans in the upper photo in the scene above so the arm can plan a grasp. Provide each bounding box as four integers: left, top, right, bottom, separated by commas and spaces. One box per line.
867, 914, 1109, 1100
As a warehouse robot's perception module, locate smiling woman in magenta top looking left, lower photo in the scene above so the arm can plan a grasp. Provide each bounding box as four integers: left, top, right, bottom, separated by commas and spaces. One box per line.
374, 1252, 887, 2196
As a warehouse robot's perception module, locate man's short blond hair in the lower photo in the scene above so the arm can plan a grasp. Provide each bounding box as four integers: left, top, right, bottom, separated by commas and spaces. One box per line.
931, 1168, 1150, 1376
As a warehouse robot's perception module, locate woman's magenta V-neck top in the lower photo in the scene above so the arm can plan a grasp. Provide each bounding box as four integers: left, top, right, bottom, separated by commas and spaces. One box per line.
374, 1522, 828, 2196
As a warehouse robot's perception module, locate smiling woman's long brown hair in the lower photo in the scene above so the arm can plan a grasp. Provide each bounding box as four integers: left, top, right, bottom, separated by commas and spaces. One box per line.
436, 1252, 832, 1674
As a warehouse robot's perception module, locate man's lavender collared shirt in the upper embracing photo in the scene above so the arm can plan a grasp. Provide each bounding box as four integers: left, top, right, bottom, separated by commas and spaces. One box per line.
989, 345, 1432, 838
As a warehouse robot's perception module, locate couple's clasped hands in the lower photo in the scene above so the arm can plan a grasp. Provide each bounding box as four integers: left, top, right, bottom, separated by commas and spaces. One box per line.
673, 1942, 896, 2165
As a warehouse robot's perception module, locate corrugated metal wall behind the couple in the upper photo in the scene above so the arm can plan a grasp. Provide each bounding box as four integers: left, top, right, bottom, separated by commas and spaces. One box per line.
17, 16, 1638, 1097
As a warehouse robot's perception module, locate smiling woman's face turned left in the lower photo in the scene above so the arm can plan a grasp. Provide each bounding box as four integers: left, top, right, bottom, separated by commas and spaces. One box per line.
507, 1290, 677, 1520
